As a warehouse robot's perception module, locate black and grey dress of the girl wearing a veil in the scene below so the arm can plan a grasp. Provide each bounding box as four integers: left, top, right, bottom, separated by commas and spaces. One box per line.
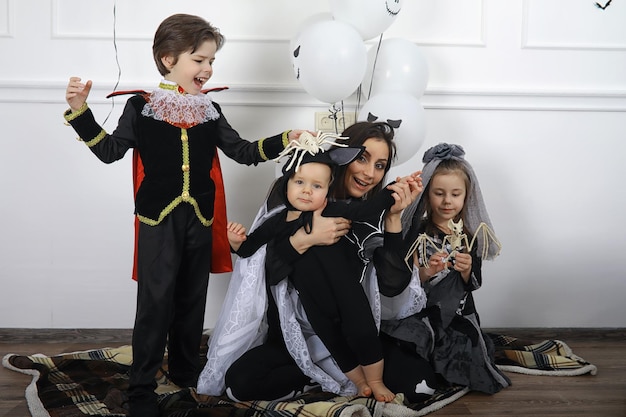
378, 226, 511, 394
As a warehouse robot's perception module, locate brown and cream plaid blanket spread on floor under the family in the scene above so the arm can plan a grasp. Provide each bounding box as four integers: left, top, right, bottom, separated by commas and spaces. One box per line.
2, 335, 596, 417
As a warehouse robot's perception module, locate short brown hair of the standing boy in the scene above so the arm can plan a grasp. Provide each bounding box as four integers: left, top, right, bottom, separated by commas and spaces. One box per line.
152, 14, 224, 75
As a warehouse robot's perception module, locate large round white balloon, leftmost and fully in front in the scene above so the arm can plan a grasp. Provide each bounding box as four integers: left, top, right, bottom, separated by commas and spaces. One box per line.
293, 20, 367, 104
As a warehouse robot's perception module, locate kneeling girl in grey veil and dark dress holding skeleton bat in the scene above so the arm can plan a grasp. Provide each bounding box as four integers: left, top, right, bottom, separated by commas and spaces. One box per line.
378, 143, 510, 394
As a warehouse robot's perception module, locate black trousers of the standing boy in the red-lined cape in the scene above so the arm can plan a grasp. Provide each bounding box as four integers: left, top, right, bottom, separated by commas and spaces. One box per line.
129, 204, 212, 403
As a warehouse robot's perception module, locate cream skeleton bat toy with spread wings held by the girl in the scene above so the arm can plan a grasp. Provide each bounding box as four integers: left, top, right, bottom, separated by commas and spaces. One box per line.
406, 219, 502, 270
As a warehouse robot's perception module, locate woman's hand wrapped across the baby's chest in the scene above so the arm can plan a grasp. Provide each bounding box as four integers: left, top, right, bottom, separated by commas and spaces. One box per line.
289, 202, 351, 254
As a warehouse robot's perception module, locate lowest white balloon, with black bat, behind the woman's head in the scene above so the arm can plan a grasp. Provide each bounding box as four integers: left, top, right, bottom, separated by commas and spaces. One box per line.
358, 92, 426, 165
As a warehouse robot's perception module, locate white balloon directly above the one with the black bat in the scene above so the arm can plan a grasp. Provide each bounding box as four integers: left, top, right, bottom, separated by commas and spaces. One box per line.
362, 38, 428, 98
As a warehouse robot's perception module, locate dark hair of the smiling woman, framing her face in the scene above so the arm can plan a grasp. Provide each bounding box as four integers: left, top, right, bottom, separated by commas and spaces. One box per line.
331, 122, 396, 199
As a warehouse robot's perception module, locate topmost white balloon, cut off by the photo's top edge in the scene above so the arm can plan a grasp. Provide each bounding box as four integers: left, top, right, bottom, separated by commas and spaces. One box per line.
330, 0, 402, 40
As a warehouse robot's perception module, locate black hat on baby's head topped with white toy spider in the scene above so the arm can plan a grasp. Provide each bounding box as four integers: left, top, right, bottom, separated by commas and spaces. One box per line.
274, 132, 365, 175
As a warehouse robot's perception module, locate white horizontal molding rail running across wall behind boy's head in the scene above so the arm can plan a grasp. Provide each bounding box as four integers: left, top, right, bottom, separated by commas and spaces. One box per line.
0, 80, 626, 112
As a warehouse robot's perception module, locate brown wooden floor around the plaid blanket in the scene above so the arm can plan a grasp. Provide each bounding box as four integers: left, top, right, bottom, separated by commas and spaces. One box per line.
0, 329, 626, 417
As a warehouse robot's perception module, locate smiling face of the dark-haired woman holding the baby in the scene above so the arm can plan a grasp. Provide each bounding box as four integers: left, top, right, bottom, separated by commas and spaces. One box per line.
344, 138, 389, 198
